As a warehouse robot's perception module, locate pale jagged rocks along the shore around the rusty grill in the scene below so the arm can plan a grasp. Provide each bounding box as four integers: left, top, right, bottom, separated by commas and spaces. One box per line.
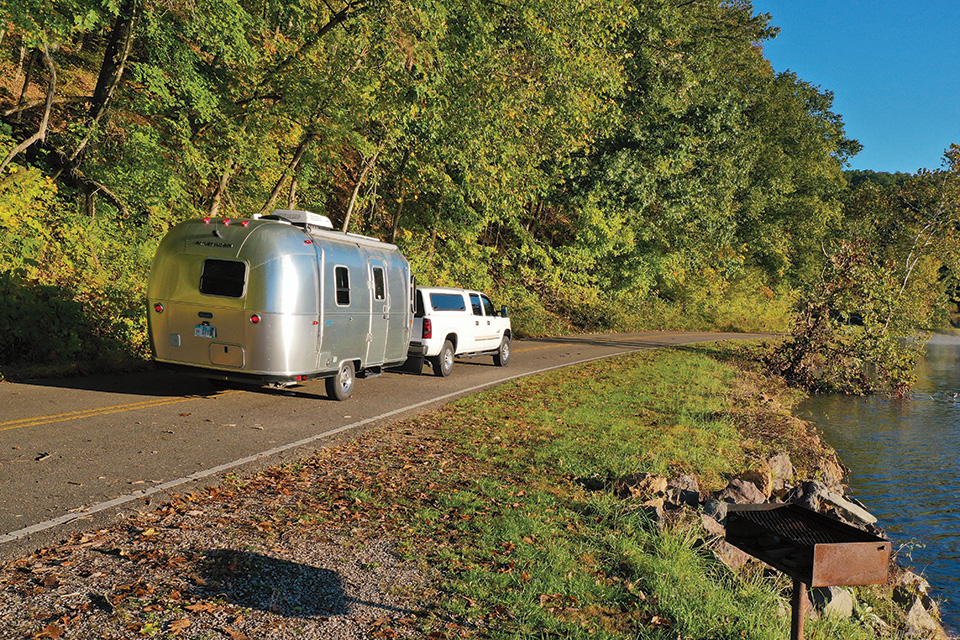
613, 440, 956, 640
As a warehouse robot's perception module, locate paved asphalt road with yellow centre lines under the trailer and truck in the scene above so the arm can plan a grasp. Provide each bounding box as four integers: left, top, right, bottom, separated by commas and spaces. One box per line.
0, 332, 761, 556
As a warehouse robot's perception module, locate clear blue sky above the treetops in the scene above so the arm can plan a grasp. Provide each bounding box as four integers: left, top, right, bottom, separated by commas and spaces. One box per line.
753, 0, 960, 173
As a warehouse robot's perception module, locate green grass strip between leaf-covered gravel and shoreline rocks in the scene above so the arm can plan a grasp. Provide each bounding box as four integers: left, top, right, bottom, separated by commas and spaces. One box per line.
404, 350, 892, 640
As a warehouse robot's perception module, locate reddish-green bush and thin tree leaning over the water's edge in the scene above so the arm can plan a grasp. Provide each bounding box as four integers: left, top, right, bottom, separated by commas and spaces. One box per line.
770, 145, 960, 393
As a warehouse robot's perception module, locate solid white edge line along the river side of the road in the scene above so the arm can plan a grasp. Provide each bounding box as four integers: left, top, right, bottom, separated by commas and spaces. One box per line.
0, 340, 728, 544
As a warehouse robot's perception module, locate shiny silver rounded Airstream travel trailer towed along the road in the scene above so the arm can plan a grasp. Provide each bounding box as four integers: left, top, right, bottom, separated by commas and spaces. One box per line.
147, 210, 413, 400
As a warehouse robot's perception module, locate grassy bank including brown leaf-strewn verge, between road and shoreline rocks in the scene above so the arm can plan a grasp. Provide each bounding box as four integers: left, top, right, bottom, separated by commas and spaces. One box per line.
8, 347, 904, 640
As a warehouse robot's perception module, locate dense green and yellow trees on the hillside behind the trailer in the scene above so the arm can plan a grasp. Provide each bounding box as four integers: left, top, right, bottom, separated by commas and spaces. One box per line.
0, 0, 944, 378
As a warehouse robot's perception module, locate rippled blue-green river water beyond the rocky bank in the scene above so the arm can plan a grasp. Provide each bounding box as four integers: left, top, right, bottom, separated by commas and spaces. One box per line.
797, 336, 960, 629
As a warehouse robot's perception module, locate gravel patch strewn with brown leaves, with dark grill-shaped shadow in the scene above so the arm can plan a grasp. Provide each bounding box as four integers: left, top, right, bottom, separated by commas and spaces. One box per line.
0, 422, 457, 640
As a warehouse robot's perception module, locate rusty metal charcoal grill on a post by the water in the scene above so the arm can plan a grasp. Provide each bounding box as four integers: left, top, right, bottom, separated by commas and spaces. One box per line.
726, 504, 890, 640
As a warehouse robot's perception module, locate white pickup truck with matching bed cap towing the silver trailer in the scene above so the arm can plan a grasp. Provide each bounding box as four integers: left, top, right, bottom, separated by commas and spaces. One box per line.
404, 287, 513, 377
